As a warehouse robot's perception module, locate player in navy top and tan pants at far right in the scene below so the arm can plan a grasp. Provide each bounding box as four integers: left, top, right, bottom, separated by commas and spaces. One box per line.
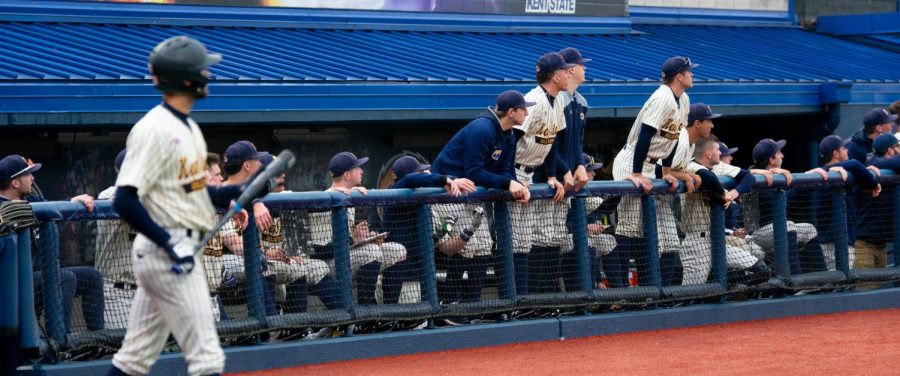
853, 134, 900, 269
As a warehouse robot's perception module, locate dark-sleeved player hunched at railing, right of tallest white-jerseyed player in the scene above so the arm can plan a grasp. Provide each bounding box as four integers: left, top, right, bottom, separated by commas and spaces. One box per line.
679, 137, 771, 285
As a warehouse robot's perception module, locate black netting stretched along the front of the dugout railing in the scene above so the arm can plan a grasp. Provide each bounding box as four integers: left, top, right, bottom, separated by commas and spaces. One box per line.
24, 172, 900, 362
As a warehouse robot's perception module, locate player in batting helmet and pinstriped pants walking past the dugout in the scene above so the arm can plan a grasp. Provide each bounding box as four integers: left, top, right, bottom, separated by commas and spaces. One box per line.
108, 36, 258, 375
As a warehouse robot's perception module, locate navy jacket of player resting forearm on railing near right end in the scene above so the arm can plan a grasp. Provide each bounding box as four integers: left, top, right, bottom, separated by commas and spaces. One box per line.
812, 159, 878, 245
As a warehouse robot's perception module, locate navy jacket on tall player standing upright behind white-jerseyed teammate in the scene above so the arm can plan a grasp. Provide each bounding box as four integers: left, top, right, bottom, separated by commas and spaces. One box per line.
533, 93, 588, 183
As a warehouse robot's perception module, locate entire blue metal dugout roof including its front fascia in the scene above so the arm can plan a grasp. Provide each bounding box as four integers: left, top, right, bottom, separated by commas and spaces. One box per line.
0, 1, 900, 127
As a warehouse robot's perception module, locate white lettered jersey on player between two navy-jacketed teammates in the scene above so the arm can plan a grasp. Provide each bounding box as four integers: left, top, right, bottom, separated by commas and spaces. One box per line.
513, 85, 566, 167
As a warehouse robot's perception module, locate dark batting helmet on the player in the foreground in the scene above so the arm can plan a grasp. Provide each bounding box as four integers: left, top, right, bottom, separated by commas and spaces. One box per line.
148, 35, 222, 93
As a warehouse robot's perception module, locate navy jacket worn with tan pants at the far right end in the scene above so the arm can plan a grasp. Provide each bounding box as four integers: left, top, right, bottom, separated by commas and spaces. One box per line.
856, 155, 900, 245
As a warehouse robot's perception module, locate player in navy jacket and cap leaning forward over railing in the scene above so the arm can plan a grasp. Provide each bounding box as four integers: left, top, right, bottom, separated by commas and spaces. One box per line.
431, 90, 534, 292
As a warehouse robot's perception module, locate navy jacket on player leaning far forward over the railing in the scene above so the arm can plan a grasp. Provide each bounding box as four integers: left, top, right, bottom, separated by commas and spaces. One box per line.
431, 111, 516, 189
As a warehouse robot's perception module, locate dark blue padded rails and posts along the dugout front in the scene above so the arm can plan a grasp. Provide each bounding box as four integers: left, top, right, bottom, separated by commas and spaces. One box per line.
8, 171, 900, 358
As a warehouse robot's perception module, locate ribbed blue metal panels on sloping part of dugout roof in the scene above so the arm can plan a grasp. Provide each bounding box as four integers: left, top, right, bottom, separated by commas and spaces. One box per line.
0, 22, 900, 84
